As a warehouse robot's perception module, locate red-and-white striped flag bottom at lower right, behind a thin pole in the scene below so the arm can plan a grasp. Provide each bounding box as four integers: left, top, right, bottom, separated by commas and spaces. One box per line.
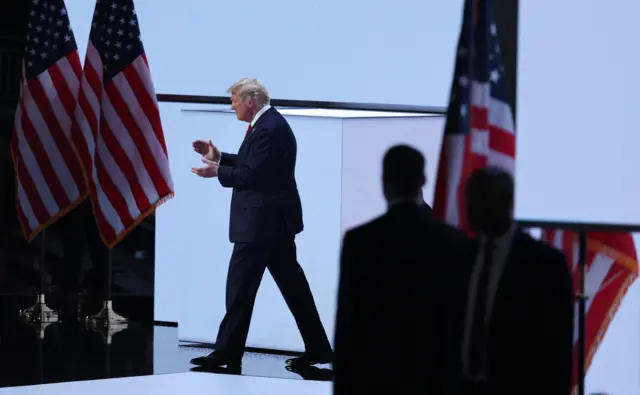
542, 230, 638, 388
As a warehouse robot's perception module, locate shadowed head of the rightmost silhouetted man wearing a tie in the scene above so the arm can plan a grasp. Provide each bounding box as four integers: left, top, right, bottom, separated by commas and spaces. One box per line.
465, 167, 514, 237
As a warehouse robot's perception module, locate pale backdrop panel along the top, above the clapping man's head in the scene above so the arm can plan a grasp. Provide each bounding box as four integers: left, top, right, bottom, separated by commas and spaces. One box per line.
66, 0, 463, 106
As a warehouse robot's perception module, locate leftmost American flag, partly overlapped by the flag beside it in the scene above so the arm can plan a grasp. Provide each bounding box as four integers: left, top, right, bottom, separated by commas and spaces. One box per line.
11, 0, 87, 241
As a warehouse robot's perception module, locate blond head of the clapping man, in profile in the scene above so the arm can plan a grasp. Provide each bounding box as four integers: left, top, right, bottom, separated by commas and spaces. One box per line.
227, 78, 271, 122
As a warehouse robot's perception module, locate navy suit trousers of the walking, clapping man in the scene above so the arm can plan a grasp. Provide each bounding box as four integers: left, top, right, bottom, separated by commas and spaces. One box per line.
215, 236, 331, 358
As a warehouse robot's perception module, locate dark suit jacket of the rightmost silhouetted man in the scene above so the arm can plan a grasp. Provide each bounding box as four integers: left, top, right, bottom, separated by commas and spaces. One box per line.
453, 231, 574, 395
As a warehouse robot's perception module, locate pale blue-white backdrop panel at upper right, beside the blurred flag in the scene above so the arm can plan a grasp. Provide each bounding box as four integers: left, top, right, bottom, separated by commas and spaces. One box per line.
516, 0, 640, 224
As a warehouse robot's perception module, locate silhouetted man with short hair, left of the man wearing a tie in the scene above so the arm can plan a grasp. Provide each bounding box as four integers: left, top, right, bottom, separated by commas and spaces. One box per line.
334, 145, 466, 395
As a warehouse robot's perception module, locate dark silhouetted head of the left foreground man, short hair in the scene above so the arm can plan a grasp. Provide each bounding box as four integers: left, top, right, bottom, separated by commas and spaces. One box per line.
382, 145, 426, 202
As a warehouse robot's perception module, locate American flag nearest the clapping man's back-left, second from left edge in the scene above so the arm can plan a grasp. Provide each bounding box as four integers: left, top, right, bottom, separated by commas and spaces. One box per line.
73, 0, 173, 247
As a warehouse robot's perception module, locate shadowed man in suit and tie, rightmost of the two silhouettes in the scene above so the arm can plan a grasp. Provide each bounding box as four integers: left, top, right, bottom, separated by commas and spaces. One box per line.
458, 168, 573, 395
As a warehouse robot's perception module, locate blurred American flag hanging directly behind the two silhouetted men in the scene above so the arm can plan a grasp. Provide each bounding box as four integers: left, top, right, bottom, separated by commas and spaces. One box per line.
433, 0, 516, 231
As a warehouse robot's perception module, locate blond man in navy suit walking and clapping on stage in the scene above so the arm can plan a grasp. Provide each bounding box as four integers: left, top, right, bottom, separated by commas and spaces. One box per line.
192, 78, 332, 368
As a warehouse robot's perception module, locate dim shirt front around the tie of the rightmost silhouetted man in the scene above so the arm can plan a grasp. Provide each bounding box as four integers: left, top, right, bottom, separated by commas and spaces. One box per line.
462, 224, 516, 381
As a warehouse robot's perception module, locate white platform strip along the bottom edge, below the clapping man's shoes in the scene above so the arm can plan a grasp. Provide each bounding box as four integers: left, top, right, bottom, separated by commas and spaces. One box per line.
0, 373, 332, 395
